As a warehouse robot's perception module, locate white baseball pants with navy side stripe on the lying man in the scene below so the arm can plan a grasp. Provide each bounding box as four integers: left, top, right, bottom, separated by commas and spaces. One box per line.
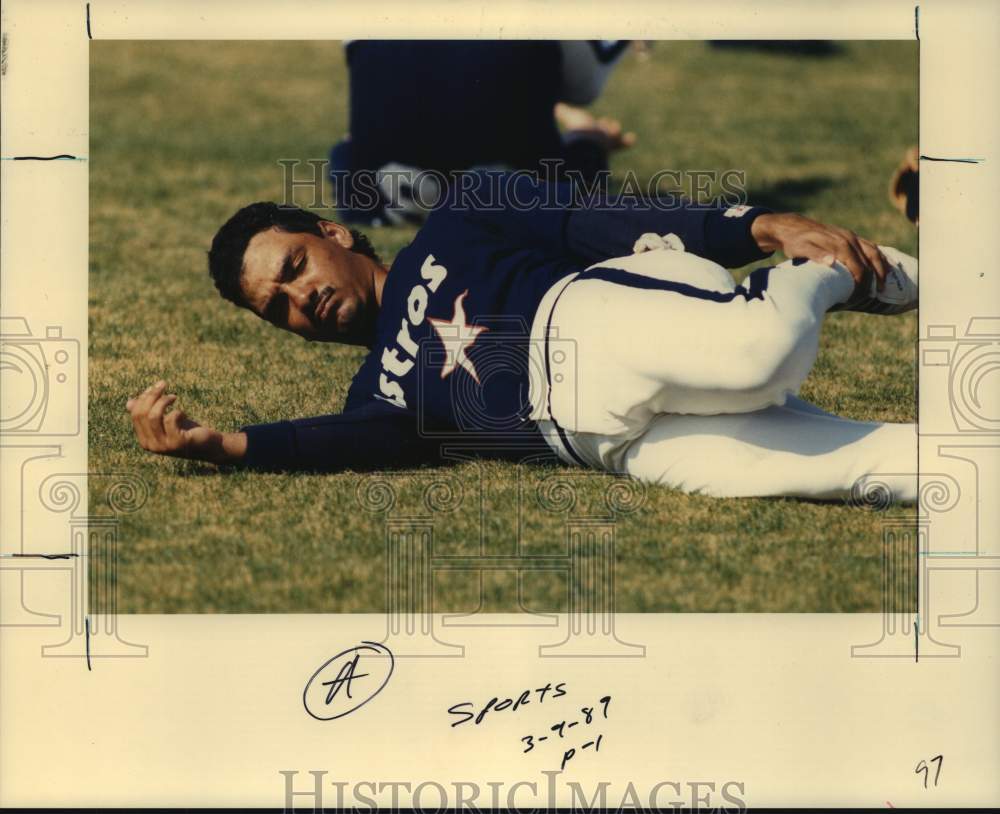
532, 250, 917, 501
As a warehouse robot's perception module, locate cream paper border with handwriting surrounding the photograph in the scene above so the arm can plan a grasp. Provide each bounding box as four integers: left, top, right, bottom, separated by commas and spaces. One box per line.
0, 0, 1000, 808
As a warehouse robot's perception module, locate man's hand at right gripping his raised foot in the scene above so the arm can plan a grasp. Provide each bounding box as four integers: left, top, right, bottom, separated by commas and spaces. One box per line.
750, 213, 889, 291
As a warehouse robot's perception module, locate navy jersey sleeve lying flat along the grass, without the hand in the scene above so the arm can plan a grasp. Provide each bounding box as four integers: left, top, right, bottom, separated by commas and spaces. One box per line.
241, 402, 442, 472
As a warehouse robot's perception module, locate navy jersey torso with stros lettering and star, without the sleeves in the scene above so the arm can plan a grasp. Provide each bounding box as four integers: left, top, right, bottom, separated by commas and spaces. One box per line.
345, 195, 581, 435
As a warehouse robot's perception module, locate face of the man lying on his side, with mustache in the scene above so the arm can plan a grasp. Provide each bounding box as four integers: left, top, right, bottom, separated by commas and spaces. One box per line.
240, 221, 376, 344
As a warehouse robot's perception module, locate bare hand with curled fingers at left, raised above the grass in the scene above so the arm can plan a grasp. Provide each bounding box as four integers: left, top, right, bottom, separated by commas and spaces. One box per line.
125, 381, 247, 464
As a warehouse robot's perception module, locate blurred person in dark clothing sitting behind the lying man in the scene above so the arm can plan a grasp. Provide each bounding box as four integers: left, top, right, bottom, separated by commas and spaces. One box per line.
330, 40, 635, 225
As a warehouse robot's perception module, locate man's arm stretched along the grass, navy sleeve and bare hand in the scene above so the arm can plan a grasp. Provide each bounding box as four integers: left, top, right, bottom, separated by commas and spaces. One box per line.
126, 382, 441, 472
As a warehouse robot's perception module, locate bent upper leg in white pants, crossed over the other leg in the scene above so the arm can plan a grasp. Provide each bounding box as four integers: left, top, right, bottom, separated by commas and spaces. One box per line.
551, 250, 854, 439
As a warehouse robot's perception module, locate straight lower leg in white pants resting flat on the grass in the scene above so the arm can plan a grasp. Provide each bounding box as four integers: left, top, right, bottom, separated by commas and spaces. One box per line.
602, 400, 917, 501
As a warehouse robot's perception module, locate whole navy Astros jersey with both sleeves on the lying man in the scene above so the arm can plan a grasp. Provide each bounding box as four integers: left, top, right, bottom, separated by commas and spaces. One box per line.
244, 175, 766, 469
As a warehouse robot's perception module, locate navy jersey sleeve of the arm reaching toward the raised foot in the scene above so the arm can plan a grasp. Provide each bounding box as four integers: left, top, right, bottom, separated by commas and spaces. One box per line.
454, 173, 771, 268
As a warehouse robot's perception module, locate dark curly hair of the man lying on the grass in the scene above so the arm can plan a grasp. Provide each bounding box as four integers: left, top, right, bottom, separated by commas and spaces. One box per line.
208, 201, 382, 308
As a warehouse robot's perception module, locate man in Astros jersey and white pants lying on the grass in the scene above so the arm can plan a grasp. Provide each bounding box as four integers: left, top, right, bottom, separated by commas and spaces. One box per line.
127, 175, 917, 500
